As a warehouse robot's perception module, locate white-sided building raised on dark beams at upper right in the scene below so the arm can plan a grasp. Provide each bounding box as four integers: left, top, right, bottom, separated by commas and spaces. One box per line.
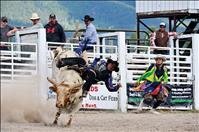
136, 0, 199, 45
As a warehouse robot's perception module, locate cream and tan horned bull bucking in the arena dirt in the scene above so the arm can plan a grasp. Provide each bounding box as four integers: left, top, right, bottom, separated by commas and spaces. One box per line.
47, 48, 86, 126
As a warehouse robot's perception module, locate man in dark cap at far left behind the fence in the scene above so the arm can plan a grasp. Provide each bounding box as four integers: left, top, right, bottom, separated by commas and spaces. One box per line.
0, 16, 17, 50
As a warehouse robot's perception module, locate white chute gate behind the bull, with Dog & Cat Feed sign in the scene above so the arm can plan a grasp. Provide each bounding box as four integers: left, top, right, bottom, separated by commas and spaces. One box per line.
47, 33, 122, 109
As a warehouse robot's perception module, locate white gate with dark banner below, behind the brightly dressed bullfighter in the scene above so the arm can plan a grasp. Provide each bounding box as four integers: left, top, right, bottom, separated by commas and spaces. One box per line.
126, 46, 193, 108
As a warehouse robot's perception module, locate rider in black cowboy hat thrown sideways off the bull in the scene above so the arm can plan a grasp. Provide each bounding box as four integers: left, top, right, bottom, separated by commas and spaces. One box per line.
82, 58, 121, 97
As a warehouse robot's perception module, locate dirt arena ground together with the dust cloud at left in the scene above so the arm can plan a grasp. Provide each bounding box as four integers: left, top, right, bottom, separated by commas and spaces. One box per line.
1, 77, 199, 132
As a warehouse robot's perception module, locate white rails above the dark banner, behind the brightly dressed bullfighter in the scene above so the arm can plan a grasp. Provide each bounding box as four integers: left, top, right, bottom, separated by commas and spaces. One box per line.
126, 46, 193, 85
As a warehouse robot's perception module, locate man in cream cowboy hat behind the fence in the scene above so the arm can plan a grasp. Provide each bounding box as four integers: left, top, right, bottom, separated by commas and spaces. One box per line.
27, 13, 44, 29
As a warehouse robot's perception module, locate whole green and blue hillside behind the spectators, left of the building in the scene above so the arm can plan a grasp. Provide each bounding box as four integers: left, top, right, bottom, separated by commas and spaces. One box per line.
1, 1, 135, 29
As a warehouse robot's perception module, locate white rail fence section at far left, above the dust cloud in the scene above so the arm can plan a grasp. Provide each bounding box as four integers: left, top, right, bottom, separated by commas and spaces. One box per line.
0, 42, 38, 82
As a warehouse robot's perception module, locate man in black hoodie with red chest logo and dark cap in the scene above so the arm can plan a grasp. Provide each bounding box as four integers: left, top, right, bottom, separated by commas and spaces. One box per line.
44, 13, 66, 46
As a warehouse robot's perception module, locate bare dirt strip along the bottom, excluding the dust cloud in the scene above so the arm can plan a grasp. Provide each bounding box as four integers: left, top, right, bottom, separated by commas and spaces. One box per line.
1, 111, 199, 132
